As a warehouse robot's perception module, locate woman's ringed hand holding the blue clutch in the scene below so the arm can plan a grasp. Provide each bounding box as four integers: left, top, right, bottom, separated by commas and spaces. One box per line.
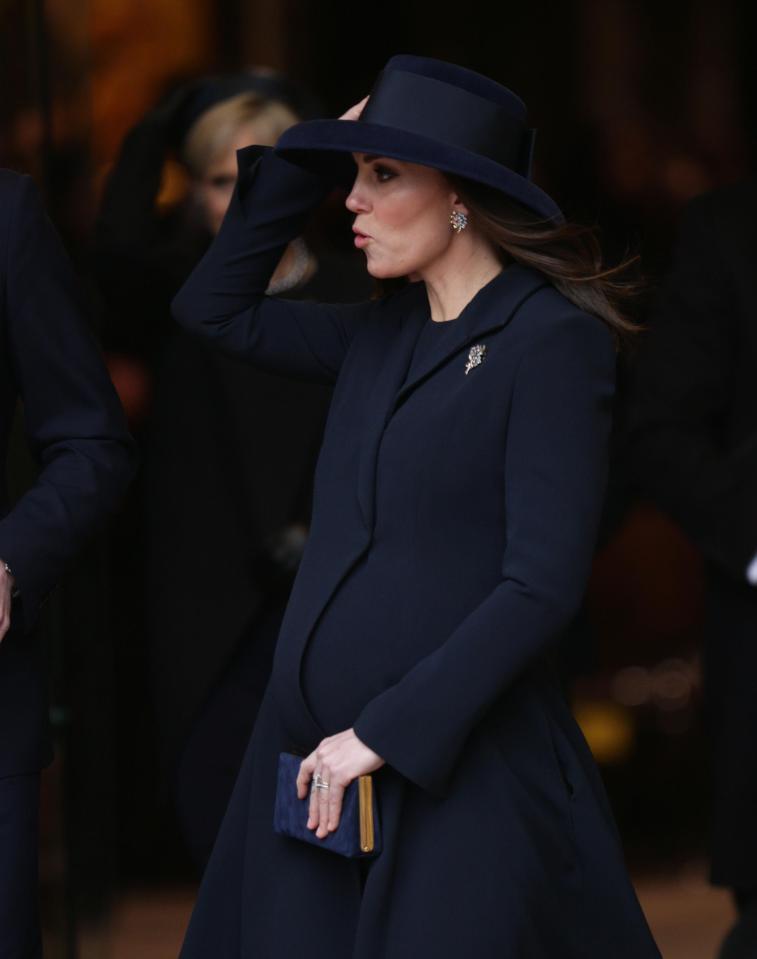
297, 729, 384, 839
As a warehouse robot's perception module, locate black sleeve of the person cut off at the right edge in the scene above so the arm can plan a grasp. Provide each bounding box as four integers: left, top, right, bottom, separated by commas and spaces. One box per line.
629, 201, 757, 582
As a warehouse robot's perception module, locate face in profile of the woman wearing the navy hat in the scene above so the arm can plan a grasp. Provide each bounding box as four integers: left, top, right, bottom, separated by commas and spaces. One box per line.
345, 153, 464, 279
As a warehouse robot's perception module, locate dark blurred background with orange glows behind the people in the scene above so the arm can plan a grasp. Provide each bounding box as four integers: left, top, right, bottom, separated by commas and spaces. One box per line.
0, 0, 757, 957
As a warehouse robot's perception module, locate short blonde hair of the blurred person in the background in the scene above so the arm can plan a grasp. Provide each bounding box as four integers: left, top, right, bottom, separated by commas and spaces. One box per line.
181, 93, 299, 177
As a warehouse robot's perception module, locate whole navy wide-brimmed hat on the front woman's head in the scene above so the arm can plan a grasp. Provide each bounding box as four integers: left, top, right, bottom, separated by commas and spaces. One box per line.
274, 54, 564, 223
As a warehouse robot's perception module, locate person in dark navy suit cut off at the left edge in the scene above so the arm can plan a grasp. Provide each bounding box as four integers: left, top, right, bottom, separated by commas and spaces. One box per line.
0, 170, 135, 959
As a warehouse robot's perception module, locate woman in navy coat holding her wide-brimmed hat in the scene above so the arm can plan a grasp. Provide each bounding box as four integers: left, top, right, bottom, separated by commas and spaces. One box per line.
174, 56, 659, 959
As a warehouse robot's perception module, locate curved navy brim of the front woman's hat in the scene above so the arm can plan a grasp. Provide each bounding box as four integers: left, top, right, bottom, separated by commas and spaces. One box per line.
274, 120, 565, 223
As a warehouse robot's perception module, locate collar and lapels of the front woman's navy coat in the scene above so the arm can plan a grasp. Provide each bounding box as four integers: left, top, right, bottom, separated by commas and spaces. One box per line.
357, 264, 548, 529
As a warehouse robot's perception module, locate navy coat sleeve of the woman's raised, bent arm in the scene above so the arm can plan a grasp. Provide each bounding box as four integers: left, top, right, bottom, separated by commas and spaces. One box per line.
172, 146, 372, 383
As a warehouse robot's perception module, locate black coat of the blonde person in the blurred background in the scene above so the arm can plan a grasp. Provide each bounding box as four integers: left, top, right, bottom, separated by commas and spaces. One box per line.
95, 99, 370, 870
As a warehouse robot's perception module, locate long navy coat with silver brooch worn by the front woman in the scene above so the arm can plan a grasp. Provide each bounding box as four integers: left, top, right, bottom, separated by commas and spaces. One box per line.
174, 147, 659, 959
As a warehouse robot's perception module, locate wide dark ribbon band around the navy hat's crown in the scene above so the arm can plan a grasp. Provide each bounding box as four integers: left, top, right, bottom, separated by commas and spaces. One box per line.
358, 70, 533, 177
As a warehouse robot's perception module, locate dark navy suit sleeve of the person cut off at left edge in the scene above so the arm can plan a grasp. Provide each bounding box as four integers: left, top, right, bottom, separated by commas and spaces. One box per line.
0, 177, 136, 628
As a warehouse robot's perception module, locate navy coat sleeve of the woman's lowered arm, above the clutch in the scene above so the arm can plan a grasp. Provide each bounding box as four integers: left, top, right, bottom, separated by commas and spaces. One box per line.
354, 311, 615, 795
